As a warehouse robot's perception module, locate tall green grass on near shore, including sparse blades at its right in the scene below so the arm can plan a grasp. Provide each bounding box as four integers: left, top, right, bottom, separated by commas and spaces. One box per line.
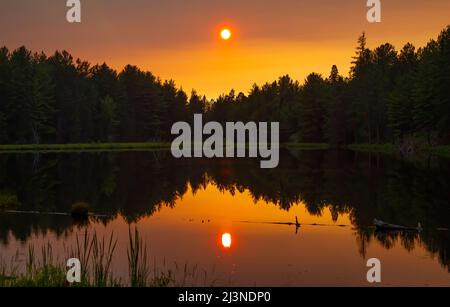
0, 227, 223, 287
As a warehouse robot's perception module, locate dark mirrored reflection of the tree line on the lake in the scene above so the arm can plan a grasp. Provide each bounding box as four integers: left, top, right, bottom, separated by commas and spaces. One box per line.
0, 151, 450, 267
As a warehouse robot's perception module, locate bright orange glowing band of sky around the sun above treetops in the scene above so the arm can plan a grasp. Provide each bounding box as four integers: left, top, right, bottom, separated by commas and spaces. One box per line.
71, 21, 450, 99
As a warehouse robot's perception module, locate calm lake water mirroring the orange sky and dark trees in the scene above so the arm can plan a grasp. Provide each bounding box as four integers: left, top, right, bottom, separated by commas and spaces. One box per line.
0, 151, 450, 286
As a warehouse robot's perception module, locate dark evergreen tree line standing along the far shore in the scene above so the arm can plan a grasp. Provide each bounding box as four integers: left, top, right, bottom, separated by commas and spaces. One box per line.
0, 26, 450, 146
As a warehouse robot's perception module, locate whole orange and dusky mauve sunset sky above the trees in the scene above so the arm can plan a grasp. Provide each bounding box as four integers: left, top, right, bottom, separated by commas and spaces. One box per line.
0, 0, 450, 98
